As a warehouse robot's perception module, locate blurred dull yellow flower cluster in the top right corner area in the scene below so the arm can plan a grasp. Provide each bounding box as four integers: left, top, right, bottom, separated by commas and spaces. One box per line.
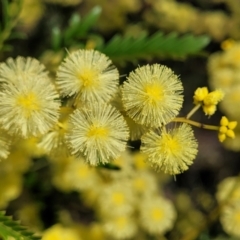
144, 0, 231, 41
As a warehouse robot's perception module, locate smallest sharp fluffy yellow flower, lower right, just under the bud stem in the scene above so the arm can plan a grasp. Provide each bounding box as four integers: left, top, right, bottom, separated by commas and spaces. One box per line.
141, 123, 198, 175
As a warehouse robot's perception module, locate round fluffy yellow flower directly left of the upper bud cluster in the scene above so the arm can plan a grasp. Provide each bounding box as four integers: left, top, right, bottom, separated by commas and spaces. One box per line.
122, 64, 183, 127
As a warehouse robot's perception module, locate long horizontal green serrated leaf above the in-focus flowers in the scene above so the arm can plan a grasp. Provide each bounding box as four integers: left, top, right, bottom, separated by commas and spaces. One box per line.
97, 32, 210, 61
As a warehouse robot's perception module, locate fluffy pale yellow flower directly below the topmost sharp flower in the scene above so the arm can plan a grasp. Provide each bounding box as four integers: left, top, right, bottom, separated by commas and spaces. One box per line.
66, 103, 129, 165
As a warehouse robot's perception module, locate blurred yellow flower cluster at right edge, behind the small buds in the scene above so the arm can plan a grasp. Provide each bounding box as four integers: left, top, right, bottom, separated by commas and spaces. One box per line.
208, 39, 240, 151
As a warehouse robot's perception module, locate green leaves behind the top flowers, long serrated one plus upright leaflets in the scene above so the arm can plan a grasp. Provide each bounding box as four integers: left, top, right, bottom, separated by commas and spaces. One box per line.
51, 6, 210, 62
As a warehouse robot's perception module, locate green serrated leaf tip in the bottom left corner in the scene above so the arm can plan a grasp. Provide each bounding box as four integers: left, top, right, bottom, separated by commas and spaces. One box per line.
0, 211, 41, 240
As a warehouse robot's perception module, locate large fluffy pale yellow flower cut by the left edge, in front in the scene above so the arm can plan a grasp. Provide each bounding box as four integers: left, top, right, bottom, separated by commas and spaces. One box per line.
0, 75, 60, 138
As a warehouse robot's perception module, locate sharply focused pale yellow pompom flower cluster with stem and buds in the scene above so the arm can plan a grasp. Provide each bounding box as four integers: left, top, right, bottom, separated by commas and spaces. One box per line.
0, 50, 236, 175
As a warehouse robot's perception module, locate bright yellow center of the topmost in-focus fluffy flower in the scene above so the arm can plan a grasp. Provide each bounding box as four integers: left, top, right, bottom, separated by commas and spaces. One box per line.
77, 69, 98, 87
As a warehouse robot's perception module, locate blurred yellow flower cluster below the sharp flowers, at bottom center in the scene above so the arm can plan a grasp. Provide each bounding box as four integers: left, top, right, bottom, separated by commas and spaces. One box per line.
43, 151, 176, 240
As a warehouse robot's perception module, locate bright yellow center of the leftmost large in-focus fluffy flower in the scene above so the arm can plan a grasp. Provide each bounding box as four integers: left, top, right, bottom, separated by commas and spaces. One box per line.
17, 93, 39, 117
